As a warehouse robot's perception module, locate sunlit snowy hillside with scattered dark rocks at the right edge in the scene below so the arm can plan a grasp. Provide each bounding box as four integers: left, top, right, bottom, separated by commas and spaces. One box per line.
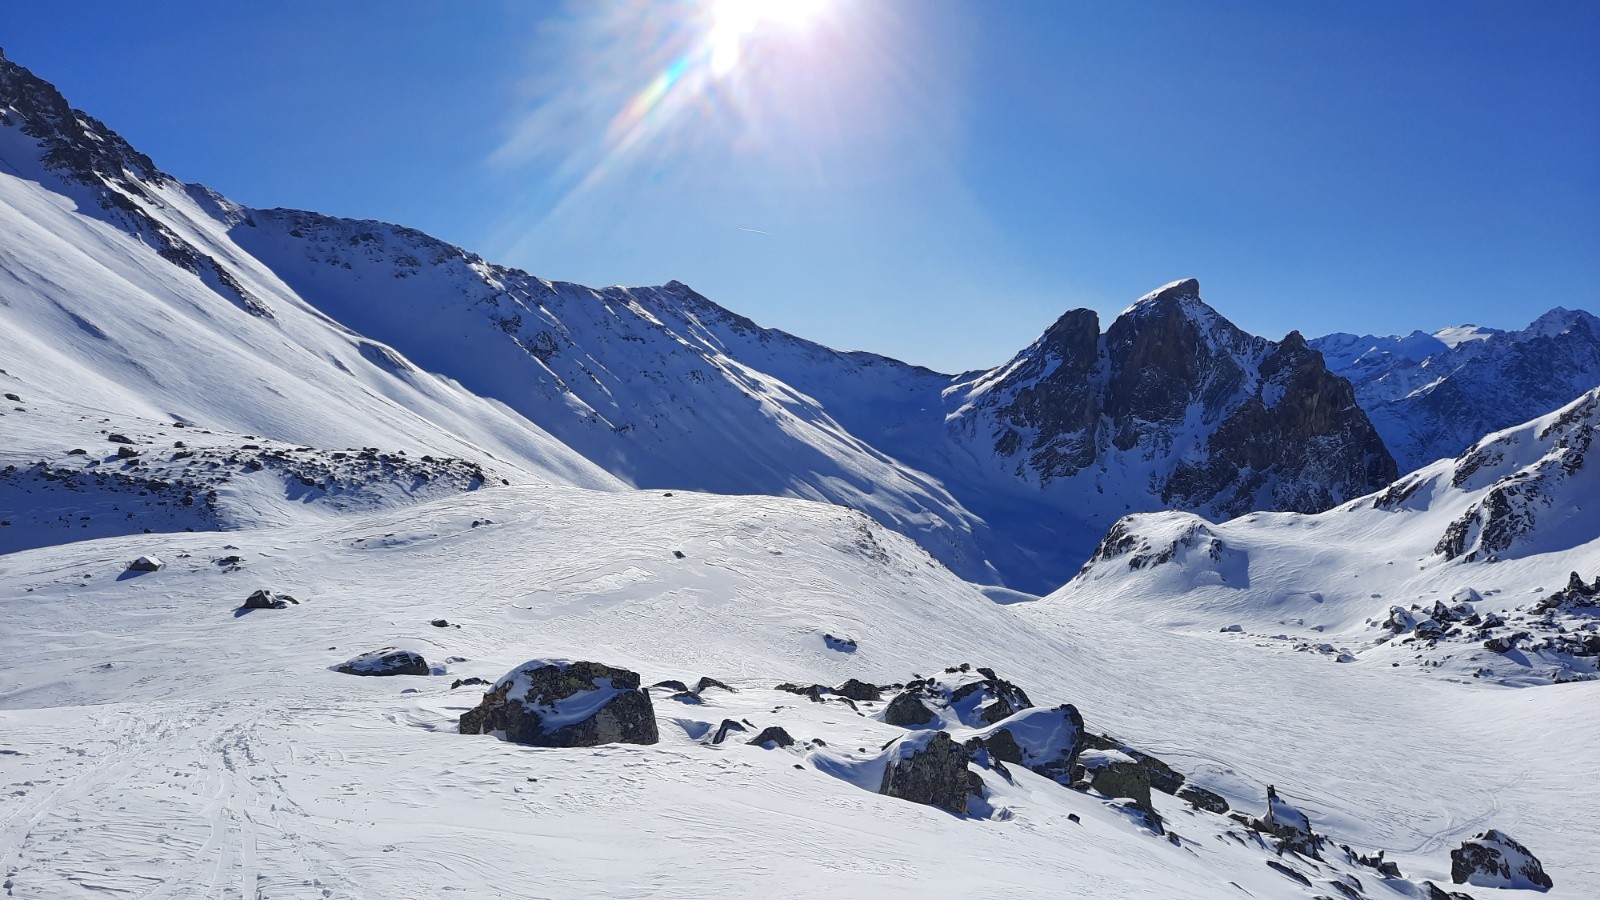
1035, 389, 1600, 684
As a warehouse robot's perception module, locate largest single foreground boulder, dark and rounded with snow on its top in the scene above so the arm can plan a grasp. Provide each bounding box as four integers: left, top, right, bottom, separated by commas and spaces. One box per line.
461, 660, 661, 746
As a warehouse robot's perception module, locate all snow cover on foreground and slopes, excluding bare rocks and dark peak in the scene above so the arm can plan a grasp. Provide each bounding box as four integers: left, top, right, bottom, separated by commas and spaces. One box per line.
0, 50, 1600, 898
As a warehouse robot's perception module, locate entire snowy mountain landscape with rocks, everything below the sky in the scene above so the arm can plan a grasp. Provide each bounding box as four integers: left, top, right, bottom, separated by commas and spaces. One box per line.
0, 49, 1600, 900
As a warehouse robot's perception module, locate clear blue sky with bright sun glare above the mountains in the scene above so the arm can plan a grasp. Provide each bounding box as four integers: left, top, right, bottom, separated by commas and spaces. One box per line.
0, 0, 1600, 370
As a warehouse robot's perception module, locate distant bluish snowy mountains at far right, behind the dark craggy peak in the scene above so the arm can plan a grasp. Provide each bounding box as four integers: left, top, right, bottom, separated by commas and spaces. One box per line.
1310, 307, 1600, 469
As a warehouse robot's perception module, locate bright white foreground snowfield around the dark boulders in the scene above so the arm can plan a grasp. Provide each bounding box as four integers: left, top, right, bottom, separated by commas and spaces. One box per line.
0, 487, 1600, 897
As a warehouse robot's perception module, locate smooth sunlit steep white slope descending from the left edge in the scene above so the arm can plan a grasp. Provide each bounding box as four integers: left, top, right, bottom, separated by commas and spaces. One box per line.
0, 50, 621, 487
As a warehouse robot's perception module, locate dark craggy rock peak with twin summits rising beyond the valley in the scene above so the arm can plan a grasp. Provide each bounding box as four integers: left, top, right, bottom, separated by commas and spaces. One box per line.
952, 279, 1398, 519
